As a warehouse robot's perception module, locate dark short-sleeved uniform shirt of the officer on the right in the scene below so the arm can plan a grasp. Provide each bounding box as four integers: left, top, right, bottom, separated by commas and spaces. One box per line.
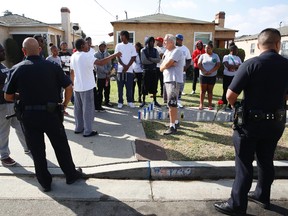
229, 50, 288, 112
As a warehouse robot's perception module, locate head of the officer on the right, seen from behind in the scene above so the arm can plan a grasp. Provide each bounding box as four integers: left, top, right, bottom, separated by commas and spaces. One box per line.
258, 28, 281, 51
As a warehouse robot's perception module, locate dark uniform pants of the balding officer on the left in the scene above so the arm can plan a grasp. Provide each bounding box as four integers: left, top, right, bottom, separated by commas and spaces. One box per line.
23, 111, 77, 187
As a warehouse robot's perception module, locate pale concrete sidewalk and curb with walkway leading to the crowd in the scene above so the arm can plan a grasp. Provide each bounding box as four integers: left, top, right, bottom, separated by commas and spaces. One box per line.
0, 106, 288, 180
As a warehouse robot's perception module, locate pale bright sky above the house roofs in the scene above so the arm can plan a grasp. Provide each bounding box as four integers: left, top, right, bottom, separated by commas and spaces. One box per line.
1, 0, 288, 44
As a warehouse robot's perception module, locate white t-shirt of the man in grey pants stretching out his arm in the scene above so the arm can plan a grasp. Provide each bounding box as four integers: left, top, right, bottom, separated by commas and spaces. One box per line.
70, 51, 97, 92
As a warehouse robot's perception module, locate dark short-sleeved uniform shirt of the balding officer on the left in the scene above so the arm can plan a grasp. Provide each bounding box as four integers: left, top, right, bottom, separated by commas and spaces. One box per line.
4, 56, 71, 105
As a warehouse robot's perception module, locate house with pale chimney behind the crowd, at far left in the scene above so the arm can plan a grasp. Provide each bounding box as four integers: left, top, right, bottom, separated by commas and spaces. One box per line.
0, 7, 82, 66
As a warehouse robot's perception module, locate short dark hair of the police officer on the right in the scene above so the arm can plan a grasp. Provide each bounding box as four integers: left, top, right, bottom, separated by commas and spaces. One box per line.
258, 28, 281, 46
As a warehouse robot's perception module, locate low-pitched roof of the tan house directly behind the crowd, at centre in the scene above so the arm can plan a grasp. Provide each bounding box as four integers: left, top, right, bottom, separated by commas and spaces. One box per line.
111, 13, 213, 25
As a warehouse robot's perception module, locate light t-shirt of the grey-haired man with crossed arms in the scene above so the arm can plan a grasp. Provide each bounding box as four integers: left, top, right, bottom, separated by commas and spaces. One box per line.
162, 48, 184, 83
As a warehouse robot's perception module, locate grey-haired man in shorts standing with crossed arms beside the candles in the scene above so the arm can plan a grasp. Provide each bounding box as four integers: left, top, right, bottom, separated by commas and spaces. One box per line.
160, 34, 184, 135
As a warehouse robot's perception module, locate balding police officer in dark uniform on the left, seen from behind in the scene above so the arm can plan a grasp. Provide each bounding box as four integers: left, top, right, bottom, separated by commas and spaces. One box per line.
5, 38, 85, 192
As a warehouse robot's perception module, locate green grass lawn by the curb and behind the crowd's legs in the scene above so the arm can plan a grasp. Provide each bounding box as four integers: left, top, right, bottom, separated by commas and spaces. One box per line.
110, 77, 288, 161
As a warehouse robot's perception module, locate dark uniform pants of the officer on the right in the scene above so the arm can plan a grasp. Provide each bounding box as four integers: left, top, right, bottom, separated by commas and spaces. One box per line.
228, 120, 284, 211
